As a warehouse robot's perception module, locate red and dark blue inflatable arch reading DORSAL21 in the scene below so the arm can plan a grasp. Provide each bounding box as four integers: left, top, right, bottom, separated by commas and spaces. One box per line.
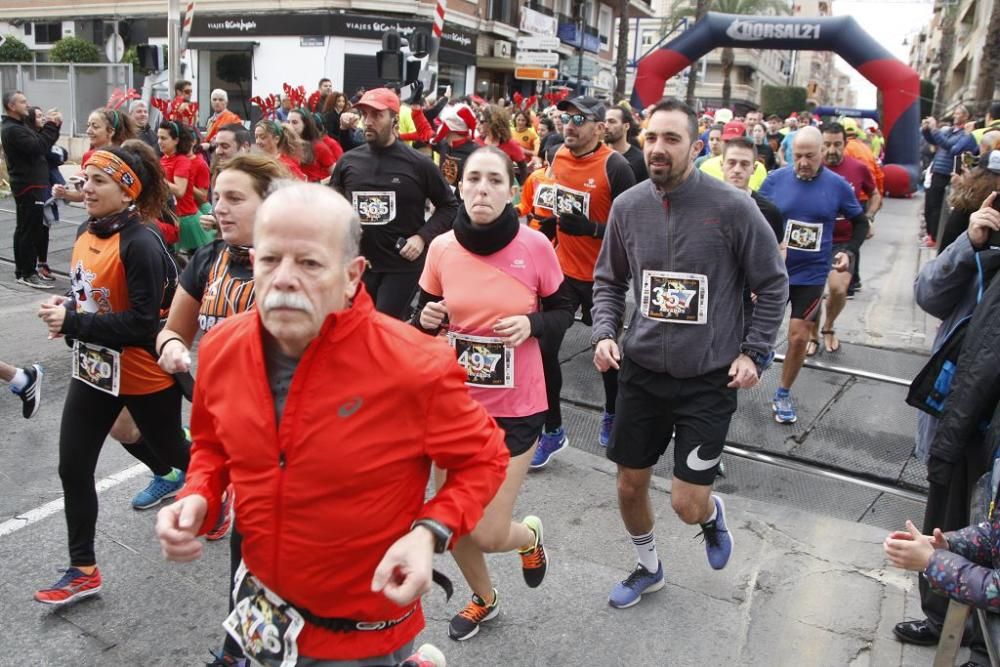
632, 12, 920, 192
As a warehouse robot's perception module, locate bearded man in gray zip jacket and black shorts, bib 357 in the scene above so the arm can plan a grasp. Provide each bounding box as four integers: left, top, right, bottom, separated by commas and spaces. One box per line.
592, 100, 788, 608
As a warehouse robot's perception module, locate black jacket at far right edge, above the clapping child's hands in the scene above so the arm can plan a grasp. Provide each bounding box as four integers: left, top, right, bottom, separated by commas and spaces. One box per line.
930, 253, 1000, 463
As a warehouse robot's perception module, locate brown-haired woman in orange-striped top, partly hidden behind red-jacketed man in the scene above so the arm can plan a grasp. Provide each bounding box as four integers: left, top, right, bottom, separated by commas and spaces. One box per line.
156, 153, 289, 667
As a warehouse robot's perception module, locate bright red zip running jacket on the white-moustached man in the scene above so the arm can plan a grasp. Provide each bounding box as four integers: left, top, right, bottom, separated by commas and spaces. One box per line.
179, 286, 509, 660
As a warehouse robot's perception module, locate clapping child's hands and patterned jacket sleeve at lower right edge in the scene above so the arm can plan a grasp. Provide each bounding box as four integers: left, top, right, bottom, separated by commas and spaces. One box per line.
883, 516, 1000, 610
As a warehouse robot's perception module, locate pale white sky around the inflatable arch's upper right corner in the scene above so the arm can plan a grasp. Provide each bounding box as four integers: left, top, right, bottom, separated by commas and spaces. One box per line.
833, 0, 934, 109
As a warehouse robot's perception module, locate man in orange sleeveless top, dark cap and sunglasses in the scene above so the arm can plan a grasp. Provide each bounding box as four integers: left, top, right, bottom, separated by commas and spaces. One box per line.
531, 97, 635, 468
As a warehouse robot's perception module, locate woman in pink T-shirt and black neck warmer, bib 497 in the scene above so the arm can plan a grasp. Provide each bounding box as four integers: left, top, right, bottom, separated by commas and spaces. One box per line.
417, 146, 573, 641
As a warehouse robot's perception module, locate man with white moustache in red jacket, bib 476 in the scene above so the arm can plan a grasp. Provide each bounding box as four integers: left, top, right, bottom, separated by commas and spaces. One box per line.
156, 184, 509, 665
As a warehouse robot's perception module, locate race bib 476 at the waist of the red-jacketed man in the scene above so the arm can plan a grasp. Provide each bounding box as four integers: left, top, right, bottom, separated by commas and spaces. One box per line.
222, 563, 305, 667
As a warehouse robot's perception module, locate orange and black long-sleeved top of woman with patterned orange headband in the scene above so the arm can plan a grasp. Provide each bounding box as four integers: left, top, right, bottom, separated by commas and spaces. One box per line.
61, 215, 177, 395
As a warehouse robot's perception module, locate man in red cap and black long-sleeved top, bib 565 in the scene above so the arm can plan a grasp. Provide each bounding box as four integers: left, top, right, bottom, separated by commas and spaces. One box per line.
330, 88, 458, 319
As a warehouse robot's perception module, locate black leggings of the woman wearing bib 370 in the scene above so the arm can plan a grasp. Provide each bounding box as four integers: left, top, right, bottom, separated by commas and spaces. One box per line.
59, 380, 190, 566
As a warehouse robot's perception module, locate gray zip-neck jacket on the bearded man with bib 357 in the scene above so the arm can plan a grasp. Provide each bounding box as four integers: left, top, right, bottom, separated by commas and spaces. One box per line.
593, 169, 788, 378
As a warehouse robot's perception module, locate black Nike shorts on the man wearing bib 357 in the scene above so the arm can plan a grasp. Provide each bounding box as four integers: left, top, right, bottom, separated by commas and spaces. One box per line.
608, 356, 736, 485
